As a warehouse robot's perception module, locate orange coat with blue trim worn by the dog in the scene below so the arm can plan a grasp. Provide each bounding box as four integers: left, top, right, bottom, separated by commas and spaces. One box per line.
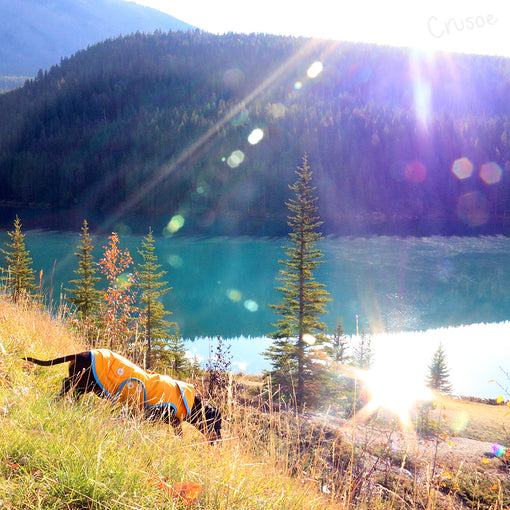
90, 349, 195, 421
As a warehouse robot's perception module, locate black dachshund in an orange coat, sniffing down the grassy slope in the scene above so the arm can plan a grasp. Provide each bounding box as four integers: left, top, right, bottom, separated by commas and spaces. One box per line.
25, 349, 221, 443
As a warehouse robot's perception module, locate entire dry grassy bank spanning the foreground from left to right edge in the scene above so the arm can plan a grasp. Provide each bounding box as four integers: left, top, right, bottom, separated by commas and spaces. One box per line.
0, 298, 510, 510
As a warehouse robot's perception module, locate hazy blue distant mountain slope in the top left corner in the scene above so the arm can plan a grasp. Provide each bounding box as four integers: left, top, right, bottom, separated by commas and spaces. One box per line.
0, 0, 193, 76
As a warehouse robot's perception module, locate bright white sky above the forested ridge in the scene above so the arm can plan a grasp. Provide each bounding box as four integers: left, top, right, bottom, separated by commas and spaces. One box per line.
128, 0, 510, 56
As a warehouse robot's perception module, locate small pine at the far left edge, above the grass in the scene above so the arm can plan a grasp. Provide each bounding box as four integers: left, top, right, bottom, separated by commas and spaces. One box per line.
2, 216, 37, 303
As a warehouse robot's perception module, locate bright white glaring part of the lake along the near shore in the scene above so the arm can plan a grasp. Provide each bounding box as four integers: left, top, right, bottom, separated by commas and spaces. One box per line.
181, 322, 510, 399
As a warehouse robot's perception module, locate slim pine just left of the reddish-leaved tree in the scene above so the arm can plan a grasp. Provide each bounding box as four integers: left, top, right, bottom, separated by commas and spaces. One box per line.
66, 220, 102, 345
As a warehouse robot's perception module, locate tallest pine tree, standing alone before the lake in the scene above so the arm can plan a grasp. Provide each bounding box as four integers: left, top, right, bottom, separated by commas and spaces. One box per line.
265, 154, 330, 405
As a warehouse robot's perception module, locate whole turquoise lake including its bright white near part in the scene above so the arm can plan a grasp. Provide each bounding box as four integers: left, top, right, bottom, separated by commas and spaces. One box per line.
0, 231, 510, 397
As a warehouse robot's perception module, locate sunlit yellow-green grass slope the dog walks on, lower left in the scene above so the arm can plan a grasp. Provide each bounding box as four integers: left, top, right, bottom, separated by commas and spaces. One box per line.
0, 300, 336, 509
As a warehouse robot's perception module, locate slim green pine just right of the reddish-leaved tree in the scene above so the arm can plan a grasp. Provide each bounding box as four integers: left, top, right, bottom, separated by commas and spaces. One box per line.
138, 229, 176, 368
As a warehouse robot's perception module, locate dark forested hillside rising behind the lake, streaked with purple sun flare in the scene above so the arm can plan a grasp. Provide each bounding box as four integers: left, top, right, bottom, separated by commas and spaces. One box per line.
0, 31, 510, 235
